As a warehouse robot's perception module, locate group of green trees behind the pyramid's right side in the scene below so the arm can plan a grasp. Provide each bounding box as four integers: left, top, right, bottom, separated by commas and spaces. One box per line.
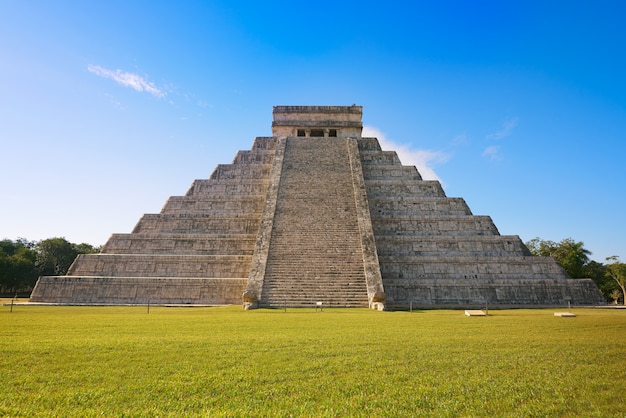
526, 238, 626, 305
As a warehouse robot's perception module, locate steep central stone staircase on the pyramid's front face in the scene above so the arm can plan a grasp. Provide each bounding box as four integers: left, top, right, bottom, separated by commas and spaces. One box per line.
261, 138, 368, 307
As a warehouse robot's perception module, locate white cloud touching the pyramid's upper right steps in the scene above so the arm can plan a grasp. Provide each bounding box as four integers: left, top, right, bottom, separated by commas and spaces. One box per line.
362, 126, 450, 182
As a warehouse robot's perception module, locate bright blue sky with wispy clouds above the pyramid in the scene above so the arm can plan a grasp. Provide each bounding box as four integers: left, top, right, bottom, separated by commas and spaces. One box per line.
0, 0, 626, 262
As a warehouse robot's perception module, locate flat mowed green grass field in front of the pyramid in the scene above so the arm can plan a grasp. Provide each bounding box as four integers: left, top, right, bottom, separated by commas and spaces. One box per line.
0, 306, 626, 417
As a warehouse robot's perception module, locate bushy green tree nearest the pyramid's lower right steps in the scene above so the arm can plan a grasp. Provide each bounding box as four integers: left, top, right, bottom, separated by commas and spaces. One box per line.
526, 238, 591, 278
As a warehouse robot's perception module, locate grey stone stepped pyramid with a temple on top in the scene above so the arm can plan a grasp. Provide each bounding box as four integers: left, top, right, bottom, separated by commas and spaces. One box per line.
30, 106, 603, 309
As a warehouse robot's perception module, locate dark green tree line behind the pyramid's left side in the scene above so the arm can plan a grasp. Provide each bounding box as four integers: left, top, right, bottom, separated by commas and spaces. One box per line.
0, 238, 100, 296
